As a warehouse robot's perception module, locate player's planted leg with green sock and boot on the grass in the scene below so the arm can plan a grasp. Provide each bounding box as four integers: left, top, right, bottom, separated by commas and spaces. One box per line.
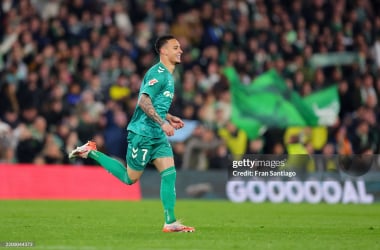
151, 138, 195, 232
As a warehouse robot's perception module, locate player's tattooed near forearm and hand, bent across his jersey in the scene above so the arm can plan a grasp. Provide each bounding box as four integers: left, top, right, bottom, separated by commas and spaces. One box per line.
138, 94, 174, 136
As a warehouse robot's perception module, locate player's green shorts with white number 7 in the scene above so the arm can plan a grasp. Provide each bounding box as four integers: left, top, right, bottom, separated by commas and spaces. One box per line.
126, 131, 173, 171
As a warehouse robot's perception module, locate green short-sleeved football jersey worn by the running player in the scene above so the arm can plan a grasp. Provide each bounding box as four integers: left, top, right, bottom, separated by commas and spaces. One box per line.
127, 62, 174, 138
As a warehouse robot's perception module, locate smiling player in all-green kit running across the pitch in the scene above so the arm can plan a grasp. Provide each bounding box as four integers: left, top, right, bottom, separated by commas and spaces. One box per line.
69, 35, 195, 232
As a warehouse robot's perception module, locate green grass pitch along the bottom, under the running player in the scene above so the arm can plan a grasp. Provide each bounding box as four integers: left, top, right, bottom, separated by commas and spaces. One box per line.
0, 200, 380, 250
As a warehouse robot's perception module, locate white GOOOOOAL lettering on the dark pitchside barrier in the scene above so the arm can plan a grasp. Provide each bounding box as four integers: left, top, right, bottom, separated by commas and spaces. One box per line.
226, 180, 374, 204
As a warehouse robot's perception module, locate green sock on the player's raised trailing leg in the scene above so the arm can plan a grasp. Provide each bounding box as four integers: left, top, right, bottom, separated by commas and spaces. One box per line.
88, 150, 133, 185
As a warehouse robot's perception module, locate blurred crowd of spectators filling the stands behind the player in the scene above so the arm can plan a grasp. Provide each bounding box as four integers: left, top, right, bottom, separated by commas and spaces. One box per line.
0, 0, 380, 170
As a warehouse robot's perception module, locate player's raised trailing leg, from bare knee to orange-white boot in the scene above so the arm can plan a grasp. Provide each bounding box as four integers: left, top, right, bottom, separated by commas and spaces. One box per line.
69, 141, 142, 185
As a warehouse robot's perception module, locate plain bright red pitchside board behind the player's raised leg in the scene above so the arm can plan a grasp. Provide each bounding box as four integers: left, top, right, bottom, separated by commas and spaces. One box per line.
0, 164, 141, 200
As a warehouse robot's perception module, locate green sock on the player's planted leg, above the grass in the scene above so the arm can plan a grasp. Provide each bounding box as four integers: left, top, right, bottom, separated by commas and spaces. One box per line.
160, 166, 177, 224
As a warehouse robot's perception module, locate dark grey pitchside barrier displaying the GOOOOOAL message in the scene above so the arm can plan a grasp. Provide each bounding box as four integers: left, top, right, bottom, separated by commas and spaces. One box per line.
140, 159, 380, 204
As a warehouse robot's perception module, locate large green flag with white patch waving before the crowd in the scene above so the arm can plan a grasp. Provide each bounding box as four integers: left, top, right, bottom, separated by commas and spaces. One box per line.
224, 67, 340, 138
